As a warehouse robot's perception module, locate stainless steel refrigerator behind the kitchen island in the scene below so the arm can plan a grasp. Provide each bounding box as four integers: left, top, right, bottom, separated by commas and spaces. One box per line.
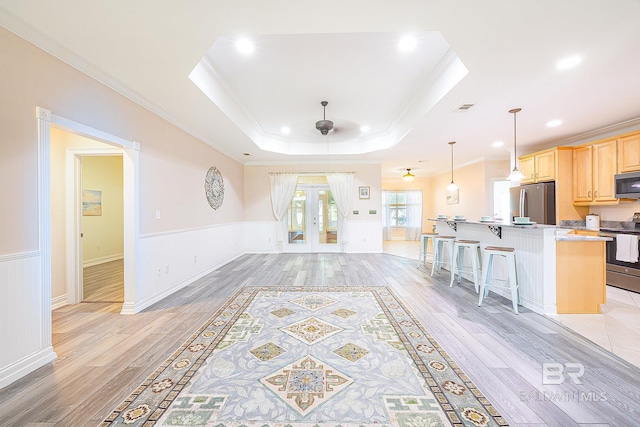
510, 182, 556, 225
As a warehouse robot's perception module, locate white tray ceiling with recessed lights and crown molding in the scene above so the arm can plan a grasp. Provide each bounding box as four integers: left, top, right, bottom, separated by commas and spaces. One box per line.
0, 0, 640, 177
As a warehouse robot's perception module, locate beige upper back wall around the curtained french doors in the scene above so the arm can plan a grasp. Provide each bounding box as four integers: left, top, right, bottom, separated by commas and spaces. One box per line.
244, 164, 382, 221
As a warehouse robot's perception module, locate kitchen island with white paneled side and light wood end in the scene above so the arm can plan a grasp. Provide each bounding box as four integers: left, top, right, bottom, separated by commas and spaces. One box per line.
430, 218, 608, 314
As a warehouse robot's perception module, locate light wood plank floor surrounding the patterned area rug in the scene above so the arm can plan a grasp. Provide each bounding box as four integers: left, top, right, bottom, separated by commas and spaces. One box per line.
0, 254, 640, 427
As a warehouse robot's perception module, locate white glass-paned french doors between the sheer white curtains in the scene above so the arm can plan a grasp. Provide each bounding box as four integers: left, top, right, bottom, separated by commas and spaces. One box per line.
283, 185, 341, 253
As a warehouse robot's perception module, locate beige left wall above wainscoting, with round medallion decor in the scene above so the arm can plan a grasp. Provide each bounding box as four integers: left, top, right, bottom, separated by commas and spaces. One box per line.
0, 28, 244, 255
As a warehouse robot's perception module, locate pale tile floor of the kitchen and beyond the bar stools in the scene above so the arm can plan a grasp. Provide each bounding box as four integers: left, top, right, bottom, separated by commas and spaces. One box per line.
383, 240, 640, 367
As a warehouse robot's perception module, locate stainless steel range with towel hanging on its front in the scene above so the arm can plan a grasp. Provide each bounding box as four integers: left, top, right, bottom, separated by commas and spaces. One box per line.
600, 212, 640, 293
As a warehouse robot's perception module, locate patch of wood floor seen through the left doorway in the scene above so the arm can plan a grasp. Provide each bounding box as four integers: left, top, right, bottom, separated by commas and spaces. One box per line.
82, 259, 124, 303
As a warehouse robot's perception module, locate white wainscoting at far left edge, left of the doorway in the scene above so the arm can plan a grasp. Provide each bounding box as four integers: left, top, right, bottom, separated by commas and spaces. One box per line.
0, 251, 55, 388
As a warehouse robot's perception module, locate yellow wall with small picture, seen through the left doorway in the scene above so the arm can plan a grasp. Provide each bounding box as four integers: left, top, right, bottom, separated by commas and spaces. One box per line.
82, 156, 124, 265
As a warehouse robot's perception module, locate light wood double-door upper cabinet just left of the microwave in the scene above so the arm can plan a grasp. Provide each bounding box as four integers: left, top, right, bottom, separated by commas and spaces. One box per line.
573, 139, 618, 206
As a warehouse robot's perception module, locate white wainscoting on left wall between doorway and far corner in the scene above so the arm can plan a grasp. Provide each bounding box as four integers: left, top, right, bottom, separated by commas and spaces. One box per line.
135, 222, 244, 314
